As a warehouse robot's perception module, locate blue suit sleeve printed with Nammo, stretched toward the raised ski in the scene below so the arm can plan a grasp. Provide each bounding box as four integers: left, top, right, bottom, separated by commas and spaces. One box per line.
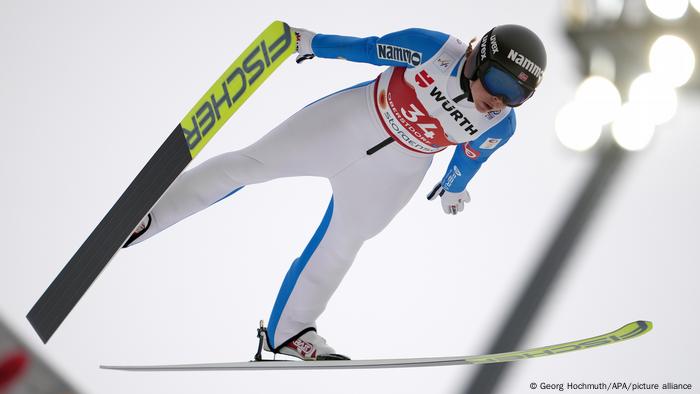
311, 28, 449, 67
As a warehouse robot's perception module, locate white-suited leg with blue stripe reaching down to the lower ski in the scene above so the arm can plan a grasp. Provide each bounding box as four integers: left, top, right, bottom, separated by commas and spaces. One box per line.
269, 152, 430, 347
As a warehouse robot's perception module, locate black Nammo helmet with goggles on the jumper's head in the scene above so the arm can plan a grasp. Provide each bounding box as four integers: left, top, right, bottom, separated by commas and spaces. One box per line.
464, 25, 547, 107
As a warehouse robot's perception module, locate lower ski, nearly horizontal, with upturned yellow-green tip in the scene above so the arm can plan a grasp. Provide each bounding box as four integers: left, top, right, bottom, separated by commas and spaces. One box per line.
100, 320, 653, 371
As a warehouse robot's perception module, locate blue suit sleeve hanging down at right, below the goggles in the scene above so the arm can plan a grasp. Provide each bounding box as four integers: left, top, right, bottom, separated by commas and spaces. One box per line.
442, 110, 515, 193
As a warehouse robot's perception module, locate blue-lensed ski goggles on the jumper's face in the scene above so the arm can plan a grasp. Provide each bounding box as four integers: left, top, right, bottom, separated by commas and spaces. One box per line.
479, 62, 535, 107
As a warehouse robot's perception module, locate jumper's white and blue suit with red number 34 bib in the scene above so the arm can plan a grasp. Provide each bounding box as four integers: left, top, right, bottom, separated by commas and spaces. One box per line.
129, 29, 515, 348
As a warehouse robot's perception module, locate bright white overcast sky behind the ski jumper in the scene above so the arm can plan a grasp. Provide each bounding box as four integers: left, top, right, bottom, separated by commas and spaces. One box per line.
0, 0, 700, 394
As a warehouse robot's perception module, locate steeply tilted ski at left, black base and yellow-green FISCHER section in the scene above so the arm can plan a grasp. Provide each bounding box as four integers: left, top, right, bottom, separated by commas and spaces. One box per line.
27, 21, 296, 343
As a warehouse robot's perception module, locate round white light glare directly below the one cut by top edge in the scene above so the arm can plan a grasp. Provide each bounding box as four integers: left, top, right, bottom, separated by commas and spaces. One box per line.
649, 35, 695, 87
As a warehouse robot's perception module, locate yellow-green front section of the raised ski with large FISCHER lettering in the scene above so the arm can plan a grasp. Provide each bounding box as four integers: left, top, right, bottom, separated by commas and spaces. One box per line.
180, 24, 292, 151
